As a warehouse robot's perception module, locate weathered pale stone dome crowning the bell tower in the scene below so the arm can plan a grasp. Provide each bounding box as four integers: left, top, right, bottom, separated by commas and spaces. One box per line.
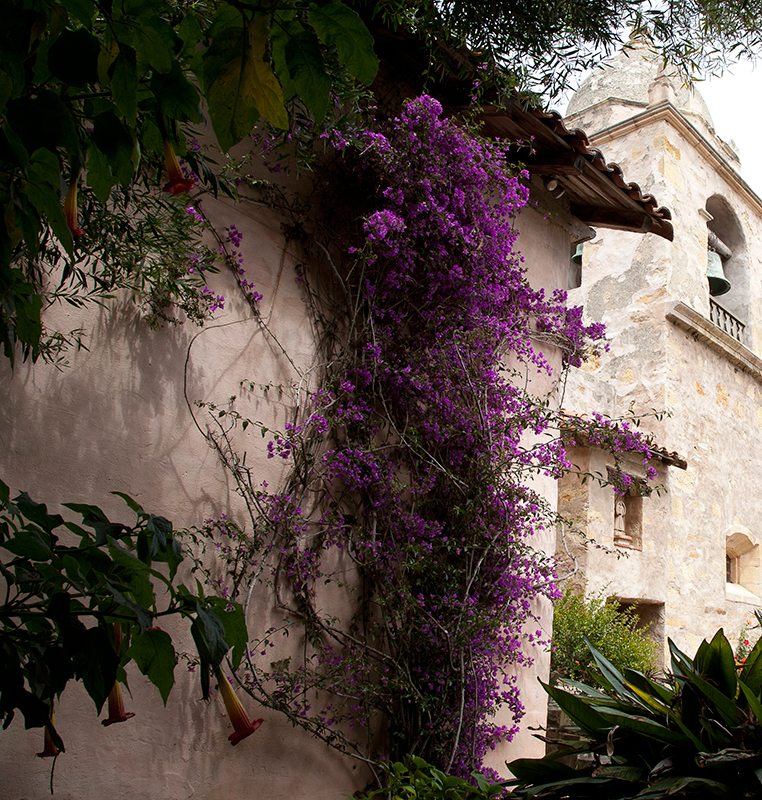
566, 38, 714, 139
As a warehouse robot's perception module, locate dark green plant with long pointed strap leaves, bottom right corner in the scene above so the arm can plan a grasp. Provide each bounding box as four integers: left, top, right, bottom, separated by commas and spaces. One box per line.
508, 630, 762, 800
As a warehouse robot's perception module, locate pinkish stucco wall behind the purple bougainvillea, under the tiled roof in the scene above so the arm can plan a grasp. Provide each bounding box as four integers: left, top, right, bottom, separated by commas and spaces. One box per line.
0, 186, 569, 800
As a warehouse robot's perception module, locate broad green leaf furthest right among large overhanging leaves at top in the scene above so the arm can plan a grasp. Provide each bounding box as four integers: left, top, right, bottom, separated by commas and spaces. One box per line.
308, 0, 378, 85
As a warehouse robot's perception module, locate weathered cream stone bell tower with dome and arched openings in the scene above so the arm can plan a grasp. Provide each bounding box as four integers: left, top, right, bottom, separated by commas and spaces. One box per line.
558, 40, 762, 653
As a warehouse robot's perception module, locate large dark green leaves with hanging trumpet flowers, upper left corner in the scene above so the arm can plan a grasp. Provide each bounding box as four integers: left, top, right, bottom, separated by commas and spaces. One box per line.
0, 0, 378, 363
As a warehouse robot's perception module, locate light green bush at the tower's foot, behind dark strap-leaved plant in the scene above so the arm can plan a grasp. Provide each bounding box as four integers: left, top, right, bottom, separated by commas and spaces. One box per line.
551, 585, 657, 684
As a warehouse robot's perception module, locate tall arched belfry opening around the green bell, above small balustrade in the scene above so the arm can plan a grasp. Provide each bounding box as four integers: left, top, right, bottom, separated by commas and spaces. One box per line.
706, 194, 751, 328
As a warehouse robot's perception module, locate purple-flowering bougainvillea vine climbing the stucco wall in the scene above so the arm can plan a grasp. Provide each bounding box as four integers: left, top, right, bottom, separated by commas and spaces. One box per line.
189, 97, 648, 776
